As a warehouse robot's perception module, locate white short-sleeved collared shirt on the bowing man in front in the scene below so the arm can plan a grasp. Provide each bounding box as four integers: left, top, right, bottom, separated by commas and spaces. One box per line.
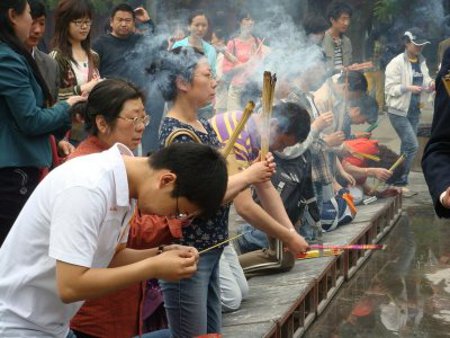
0, 144, 135, 338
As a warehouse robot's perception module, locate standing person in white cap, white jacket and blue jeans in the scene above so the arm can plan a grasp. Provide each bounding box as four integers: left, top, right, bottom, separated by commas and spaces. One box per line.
385, 28, 434, 197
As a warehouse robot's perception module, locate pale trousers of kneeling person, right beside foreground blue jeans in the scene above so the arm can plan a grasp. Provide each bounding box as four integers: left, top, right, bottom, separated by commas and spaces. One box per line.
220, 244, 248, 312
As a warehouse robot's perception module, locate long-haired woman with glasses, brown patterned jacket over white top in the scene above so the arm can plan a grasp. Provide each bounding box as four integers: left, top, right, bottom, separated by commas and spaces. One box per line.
50, 0, 100, 145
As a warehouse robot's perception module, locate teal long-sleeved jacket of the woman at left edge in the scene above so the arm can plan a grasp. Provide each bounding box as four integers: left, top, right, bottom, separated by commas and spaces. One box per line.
0, 42, 70, 168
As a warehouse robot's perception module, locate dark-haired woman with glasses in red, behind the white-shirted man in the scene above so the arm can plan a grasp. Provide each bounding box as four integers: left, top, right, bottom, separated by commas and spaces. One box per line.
68, 79, 173, 338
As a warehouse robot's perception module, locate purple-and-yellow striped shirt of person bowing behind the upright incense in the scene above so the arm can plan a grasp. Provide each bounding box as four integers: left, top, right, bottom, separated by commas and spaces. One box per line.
210, 111, 260, 168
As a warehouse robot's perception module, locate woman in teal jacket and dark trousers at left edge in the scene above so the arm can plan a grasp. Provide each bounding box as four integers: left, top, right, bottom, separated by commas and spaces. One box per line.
0, 0, 84, 246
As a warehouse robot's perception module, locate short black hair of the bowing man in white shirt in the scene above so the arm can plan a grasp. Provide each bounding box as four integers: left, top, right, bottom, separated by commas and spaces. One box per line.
149, 143, 228, 217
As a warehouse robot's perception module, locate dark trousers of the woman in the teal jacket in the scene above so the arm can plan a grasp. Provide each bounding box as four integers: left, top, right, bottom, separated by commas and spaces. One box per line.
0, 167, 40, 246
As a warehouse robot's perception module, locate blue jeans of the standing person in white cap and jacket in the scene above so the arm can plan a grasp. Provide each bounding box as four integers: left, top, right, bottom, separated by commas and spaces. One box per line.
388, 109, 420, 186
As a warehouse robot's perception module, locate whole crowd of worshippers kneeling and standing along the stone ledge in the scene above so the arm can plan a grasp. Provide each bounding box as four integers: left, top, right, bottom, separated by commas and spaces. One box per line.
0, 0, 444, 338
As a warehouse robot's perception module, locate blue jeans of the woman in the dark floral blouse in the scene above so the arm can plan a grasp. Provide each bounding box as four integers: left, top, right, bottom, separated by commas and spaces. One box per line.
160, 249, 223, 338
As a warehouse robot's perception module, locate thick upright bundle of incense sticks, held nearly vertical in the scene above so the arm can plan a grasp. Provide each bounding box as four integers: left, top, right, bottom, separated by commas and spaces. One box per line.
261, 71, 277, 158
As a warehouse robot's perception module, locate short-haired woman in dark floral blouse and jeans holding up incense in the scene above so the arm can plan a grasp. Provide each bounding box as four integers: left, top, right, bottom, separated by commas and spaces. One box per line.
153, 47, 273, 337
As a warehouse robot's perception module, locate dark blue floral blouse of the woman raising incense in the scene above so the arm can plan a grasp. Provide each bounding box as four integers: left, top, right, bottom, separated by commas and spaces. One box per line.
159, 117, 230, 250
